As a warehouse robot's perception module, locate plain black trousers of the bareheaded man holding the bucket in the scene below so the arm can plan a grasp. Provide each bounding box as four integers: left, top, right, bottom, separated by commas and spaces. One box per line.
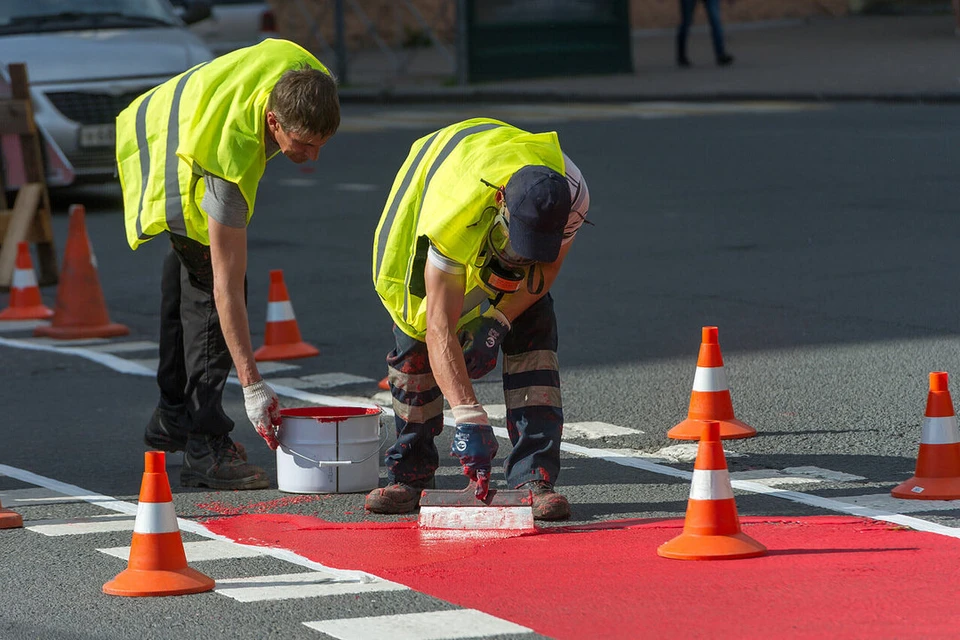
157, 234, 246, 436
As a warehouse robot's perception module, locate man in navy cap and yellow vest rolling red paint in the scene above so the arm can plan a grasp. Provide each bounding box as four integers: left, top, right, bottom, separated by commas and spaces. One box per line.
365, 118, 590, 520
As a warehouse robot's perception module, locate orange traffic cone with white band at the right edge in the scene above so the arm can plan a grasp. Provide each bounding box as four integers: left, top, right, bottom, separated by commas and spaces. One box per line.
890, 371, 960, 500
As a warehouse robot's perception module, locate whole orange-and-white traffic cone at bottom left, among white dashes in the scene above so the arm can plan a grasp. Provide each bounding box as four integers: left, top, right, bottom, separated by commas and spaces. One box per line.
103, 451, 214, 596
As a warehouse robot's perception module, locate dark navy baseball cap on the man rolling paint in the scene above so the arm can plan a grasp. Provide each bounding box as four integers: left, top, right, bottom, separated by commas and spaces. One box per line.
503, 164, 571, 262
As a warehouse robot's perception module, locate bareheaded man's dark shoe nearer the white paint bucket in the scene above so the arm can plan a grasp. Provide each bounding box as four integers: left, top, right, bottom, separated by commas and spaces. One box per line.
180, 434, 270, 490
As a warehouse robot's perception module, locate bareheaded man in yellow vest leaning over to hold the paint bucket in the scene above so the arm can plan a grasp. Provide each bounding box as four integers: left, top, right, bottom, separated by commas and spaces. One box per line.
117, 39, 340, 489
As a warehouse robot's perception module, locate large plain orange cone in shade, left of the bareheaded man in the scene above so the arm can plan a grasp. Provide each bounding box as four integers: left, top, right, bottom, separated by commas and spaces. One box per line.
33, 204, 130, 340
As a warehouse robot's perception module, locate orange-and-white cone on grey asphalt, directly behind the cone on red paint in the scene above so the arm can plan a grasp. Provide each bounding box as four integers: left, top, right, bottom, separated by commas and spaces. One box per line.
667, 327, 757, 440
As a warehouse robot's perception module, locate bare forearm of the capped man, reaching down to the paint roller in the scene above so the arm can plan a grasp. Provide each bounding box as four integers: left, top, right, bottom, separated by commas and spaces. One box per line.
423, 261, 477, 400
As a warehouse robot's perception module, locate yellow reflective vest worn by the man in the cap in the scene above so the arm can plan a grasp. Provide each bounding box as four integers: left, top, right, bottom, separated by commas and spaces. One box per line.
373, 118, 564, 340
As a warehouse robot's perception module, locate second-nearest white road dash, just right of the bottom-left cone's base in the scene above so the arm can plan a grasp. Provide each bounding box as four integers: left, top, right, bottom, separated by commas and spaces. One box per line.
216, 572, 410, 602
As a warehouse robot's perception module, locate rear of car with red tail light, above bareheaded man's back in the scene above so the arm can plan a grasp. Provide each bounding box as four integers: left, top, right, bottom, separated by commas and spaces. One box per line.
171, 0, 277, 56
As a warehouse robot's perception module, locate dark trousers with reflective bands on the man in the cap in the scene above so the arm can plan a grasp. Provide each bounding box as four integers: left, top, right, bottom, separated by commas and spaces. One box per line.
385, 294, 563, 487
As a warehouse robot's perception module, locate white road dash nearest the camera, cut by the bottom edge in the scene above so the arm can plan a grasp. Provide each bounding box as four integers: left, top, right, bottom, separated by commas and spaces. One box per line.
303, 609, 533, 640
